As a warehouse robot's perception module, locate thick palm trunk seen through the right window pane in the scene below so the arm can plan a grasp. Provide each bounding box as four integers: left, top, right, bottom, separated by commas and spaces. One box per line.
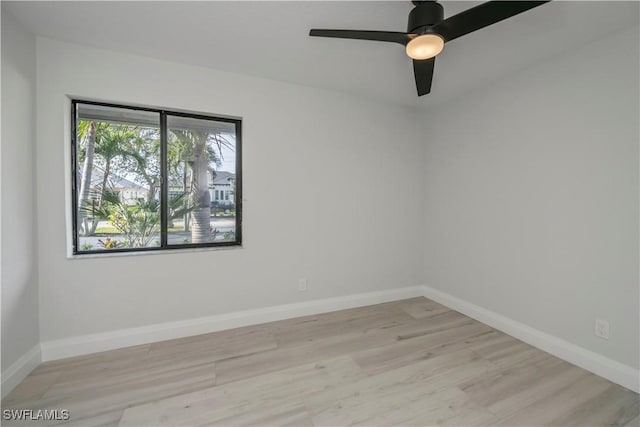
191, 139, 211, 243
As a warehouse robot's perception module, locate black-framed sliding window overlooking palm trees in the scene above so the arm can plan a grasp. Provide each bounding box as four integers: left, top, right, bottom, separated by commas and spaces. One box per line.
71, 100, 242, 254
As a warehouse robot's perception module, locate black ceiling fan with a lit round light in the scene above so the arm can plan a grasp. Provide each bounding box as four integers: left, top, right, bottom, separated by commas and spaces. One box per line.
309, 0, 549, 96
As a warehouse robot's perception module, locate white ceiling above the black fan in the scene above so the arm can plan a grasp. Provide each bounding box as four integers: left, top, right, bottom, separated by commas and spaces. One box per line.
2, 1, 639, 107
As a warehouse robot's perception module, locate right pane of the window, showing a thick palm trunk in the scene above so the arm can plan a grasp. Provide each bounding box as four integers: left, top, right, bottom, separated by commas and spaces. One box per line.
167, 115, 236, 245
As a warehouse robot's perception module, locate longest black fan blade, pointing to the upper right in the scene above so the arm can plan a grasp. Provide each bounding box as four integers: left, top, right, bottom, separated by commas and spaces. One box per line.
430, 1, 549, 42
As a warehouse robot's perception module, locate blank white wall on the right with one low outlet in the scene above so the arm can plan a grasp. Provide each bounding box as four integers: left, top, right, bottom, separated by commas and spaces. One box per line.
423, 27, 640, 368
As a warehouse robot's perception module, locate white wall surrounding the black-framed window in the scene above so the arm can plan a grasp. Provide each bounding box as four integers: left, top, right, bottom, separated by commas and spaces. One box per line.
37, 39, 423, 341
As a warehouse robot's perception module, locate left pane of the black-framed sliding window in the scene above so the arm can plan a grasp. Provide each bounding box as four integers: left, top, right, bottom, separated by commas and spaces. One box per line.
74, 103, 160, 252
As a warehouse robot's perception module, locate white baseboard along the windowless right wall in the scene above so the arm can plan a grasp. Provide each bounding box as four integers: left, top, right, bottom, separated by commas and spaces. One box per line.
423, 286, 640, 393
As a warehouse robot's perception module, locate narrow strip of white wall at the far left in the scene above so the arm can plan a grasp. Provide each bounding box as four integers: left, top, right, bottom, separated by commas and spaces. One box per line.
0, 9, 40, 372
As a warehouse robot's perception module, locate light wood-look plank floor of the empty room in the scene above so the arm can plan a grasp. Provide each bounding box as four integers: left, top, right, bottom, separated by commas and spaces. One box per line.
2, 298, 640, 426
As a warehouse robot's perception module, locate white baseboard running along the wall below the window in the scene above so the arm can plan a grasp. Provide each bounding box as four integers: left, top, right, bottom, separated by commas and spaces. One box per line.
41, 286, 423, 362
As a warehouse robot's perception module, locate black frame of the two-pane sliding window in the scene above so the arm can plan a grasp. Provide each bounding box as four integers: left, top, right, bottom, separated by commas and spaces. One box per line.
71, 98, 242, 256
